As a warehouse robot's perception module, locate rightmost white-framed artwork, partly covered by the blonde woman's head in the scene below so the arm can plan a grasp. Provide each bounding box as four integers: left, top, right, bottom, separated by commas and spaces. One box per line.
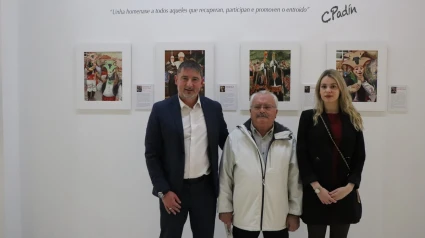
327, 42, 387, 111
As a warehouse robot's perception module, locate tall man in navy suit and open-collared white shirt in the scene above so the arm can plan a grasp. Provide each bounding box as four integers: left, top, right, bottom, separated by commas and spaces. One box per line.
145, 61, 229, 238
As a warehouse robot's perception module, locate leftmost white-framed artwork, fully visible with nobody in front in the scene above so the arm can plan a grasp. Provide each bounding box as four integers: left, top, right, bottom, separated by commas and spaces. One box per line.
75, 43, 131, 110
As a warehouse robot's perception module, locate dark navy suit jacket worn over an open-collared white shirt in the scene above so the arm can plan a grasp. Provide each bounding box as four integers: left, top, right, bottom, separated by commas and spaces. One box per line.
145, 95, 229, 196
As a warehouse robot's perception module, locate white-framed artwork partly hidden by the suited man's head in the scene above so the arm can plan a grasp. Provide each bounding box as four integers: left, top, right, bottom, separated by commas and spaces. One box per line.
154, 42, 214, 101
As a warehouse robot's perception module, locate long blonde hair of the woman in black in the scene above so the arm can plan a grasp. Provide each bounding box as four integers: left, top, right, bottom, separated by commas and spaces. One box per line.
313, 69, 363, 130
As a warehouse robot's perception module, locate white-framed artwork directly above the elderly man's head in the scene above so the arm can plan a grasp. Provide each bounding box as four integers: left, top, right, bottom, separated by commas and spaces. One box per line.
239, 42, 300, 110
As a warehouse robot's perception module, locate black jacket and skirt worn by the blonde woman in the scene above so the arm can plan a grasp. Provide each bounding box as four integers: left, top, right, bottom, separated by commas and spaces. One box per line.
297, 110, 366, 224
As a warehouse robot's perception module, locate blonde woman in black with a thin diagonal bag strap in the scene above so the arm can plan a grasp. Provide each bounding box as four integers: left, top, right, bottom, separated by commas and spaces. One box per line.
297, 69, 366, 238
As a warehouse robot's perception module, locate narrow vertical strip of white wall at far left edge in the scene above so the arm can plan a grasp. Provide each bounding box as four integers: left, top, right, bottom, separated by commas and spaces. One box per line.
0, 0, 21, 238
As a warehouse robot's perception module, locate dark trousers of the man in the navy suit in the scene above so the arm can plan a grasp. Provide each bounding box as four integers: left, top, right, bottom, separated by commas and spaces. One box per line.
159, 175, 217, 238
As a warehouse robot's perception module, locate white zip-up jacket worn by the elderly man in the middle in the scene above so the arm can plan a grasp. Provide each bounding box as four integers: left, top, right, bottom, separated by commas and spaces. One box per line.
217, 125, 303, 231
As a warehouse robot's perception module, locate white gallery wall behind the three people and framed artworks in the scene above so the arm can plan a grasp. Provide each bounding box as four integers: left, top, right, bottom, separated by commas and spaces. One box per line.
1, 0, 425, 238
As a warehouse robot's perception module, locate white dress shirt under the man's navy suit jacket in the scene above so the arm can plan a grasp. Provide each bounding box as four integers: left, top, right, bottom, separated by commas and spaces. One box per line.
179, 96, 210, 179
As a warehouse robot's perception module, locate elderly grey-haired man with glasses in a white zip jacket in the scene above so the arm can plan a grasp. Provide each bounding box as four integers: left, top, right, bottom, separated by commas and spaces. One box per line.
218, 91, 302, 238
